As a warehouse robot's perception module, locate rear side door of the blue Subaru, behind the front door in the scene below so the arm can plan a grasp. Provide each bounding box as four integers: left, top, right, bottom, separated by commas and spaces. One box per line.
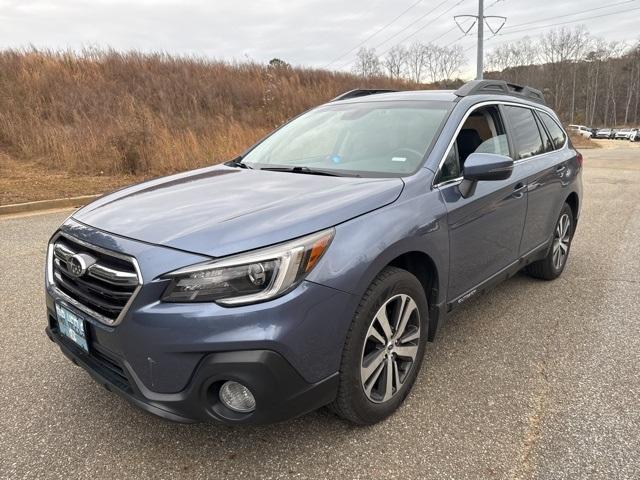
507, 110, 573, 251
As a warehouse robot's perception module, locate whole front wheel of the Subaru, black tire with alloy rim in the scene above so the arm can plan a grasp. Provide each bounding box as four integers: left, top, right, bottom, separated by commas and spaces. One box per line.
329, 267, 429, 425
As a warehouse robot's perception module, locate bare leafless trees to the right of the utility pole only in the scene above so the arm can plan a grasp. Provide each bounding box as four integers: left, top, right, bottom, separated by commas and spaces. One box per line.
487, 26, 640, 127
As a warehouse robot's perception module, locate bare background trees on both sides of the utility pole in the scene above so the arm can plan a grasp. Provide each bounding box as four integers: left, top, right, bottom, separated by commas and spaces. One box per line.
353, 26, 640, 127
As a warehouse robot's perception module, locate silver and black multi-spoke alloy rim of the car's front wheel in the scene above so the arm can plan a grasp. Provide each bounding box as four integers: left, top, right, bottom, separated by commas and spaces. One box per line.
360, 294, 420, 403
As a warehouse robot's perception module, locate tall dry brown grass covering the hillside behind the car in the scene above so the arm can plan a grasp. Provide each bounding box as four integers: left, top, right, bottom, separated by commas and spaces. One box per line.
0, 50, 420, 182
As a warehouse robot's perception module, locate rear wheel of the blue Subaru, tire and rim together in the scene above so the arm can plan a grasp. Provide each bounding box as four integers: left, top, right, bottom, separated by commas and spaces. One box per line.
526, 203, 575, 280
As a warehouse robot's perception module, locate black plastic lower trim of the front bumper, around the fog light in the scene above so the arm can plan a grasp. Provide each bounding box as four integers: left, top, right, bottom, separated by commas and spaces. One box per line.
46, 326, 338, 424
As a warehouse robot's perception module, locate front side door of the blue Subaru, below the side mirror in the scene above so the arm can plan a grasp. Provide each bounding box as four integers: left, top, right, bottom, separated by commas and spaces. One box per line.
436, 105, 527, 303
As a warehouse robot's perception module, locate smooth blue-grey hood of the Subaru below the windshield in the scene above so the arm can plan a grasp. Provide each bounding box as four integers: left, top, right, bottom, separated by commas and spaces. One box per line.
73, 166, 404, 257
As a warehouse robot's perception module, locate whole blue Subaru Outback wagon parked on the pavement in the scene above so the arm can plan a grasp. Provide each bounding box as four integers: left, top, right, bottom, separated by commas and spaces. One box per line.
46, 81, 582, 424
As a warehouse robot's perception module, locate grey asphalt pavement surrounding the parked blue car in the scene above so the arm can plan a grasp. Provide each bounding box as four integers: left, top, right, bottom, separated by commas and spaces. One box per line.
0, 142, 640, 479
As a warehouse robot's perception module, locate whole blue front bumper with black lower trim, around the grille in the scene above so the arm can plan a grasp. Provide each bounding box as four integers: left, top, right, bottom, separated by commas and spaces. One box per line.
45, 220, 357, 423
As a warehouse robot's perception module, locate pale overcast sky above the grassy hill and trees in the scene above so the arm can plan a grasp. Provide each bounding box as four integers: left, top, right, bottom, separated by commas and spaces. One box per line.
0, 0, 640, 75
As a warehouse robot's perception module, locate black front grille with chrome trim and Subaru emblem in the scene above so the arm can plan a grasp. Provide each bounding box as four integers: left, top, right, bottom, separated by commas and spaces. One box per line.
49, 233, 142, 325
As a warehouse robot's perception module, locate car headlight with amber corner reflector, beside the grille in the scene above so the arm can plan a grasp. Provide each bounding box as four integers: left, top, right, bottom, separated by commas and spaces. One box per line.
162, 228, 335, 305
